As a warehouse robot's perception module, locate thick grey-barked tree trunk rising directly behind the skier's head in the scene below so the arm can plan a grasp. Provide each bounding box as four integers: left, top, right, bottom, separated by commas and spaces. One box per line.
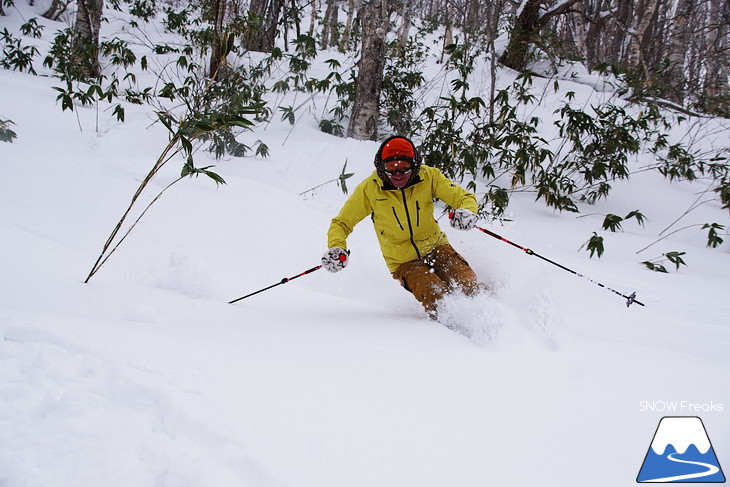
347, 0, 388, 140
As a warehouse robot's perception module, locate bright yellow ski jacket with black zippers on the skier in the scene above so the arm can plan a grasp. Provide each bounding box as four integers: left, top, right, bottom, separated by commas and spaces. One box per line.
327, 165, 477, 272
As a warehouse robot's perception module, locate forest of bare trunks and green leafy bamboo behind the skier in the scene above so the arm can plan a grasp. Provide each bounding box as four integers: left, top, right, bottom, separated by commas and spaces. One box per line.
0, 0, 730, 264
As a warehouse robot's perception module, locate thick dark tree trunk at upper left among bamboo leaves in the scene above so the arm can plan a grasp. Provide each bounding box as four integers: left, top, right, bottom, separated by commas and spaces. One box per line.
72, 0, 104, 79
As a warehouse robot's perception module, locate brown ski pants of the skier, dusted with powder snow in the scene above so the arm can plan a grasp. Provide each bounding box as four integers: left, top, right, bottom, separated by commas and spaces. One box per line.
393, 244, 486, 319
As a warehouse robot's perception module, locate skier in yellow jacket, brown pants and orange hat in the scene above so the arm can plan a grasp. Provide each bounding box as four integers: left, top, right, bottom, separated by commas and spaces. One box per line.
322, 136, 486, 319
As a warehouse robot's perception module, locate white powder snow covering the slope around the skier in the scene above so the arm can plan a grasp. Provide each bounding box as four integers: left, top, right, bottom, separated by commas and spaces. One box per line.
0, 6, 730, 487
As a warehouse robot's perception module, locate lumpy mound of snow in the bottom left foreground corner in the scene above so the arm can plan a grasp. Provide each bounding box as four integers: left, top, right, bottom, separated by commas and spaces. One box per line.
0, 326, 276, 487
